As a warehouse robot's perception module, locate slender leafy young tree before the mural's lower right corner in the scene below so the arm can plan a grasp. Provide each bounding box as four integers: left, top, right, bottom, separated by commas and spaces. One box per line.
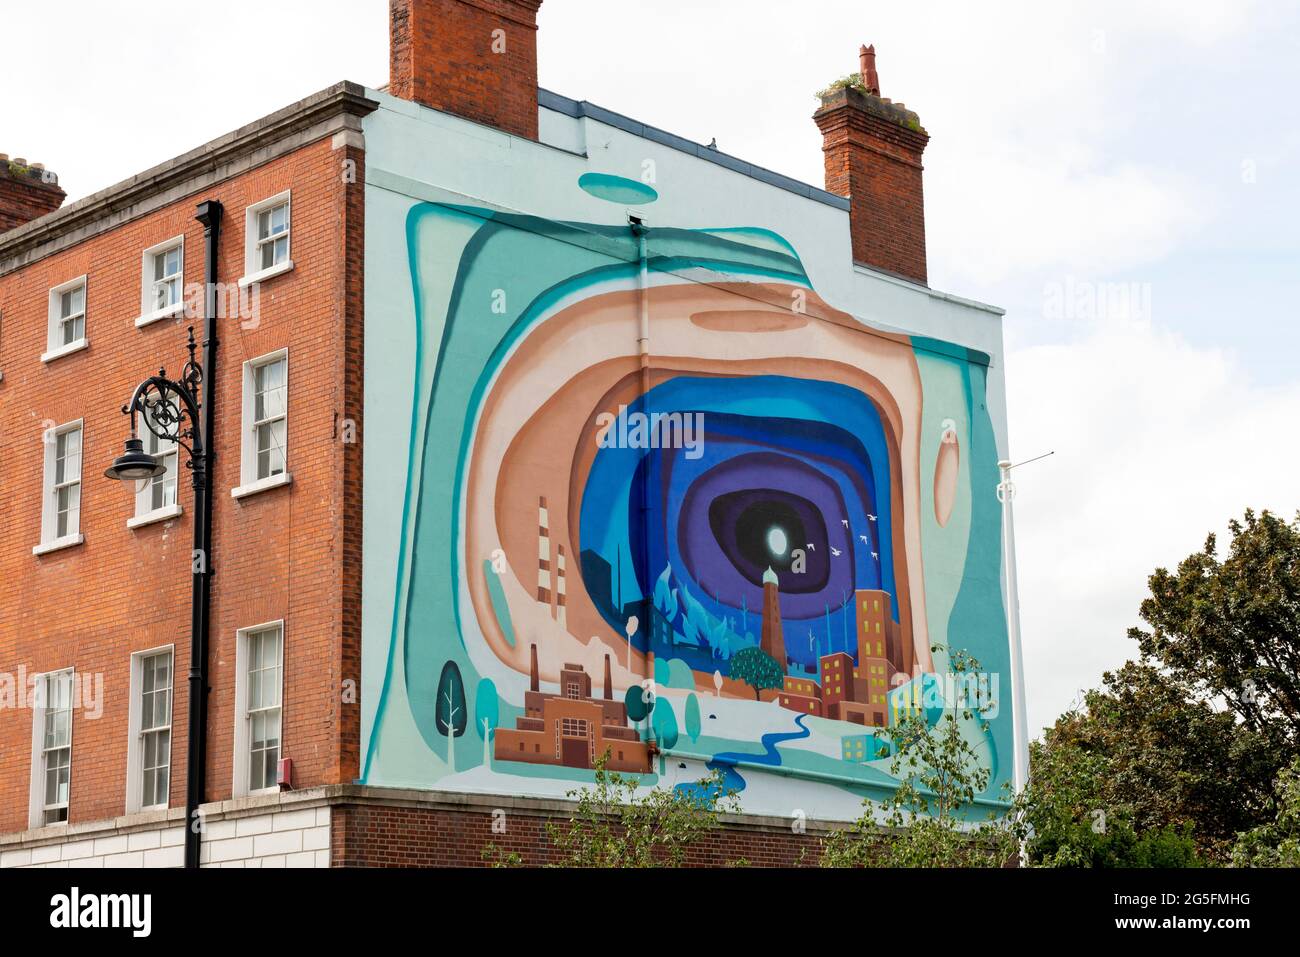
820, 649, 1021, 867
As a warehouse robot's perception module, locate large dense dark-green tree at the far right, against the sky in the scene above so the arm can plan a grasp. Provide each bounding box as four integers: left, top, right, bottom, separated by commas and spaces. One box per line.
1023, 511, 1300, 866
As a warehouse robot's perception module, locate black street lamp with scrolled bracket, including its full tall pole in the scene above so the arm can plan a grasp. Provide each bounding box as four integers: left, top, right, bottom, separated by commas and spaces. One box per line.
104, 200, 222, 869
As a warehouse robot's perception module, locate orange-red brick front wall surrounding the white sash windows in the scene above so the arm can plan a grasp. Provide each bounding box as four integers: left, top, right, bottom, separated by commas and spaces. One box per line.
0, 128, 365, 833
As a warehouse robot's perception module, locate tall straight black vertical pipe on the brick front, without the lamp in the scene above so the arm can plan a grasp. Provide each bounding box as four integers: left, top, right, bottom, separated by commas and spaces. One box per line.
185, 199, 222, 869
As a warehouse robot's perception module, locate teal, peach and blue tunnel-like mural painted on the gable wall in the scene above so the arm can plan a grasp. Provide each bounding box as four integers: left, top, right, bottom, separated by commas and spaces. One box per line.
363, 174, 1011, 818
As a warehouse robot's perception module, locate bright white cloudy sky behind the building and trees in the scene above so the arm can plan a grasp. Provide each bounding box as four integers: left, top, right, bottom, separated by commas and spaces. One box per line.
0, 0, 1300, 729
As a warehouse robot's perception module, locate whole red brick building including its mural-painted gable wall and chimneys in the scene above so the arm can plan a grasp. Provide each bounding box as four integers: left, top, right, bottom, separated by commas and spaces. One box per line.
0, 0, 1014, 866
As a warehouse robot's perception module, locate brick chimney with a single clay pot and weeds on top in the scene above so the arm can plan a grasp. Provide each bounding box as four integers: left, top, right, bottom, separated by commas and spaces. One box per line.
813, 47, 930, 285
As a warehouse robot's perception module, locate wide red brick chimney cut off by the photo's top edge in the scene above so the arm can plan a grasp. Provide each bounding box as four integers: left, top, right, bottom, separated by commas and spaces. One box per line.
389, 0, 542, 139
